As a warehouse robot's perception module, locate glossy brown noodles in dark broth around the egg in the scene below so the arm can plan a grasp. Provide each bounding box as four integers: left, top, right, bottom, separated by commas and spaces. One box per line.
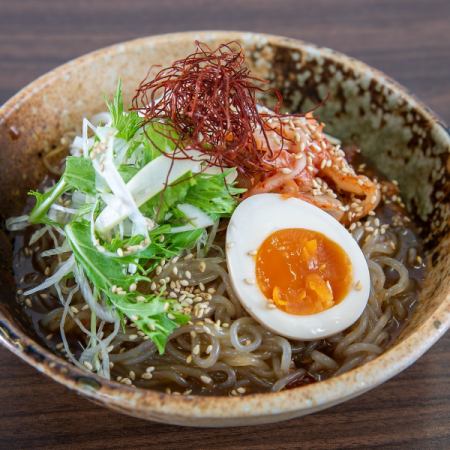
14, 140, 421, 395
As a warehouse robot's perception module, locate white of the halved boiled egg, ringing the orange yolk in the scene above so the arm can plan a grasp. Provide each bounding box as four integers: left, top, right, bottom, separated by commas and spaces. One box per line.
226, 194, 370, 340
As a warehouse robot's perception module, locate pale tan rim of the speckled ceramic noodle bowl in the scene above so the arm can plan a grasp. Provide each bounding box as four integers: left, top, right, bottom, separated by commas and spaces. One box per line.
0, 31, 450, 425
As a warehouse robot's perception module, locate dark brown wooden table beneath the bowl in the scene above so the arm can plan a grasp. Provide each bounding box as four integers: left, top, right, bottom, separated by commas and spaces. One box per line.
0, 0, 450, 449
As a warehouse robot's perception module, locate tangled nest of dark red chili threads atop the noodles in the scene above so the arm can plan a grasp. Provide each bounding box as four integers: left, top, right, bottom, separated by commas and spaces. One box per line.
132, 41, 322, 176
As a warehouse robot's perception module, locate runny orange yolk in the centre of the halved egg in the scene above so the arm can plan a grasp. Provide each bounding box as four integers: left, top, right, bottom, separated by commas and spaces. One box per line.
256, 228, 352, 315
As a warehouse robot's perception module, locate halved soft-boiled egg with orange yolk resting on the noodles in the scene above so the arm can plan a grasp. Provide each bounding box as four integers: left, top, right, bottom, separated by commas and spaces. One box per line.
226, 194, 370, 340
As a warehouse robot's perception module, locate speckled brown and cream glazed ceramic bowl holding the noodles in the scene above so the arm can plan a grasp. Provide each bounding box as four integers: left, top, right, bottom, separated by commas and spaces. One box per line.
0, 32, 450, 426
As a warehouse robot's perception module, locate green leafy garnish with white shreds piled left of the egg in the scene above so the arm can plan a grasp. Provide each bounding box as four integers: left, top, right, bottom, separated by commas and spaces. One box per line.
20, 81, 244, 353
